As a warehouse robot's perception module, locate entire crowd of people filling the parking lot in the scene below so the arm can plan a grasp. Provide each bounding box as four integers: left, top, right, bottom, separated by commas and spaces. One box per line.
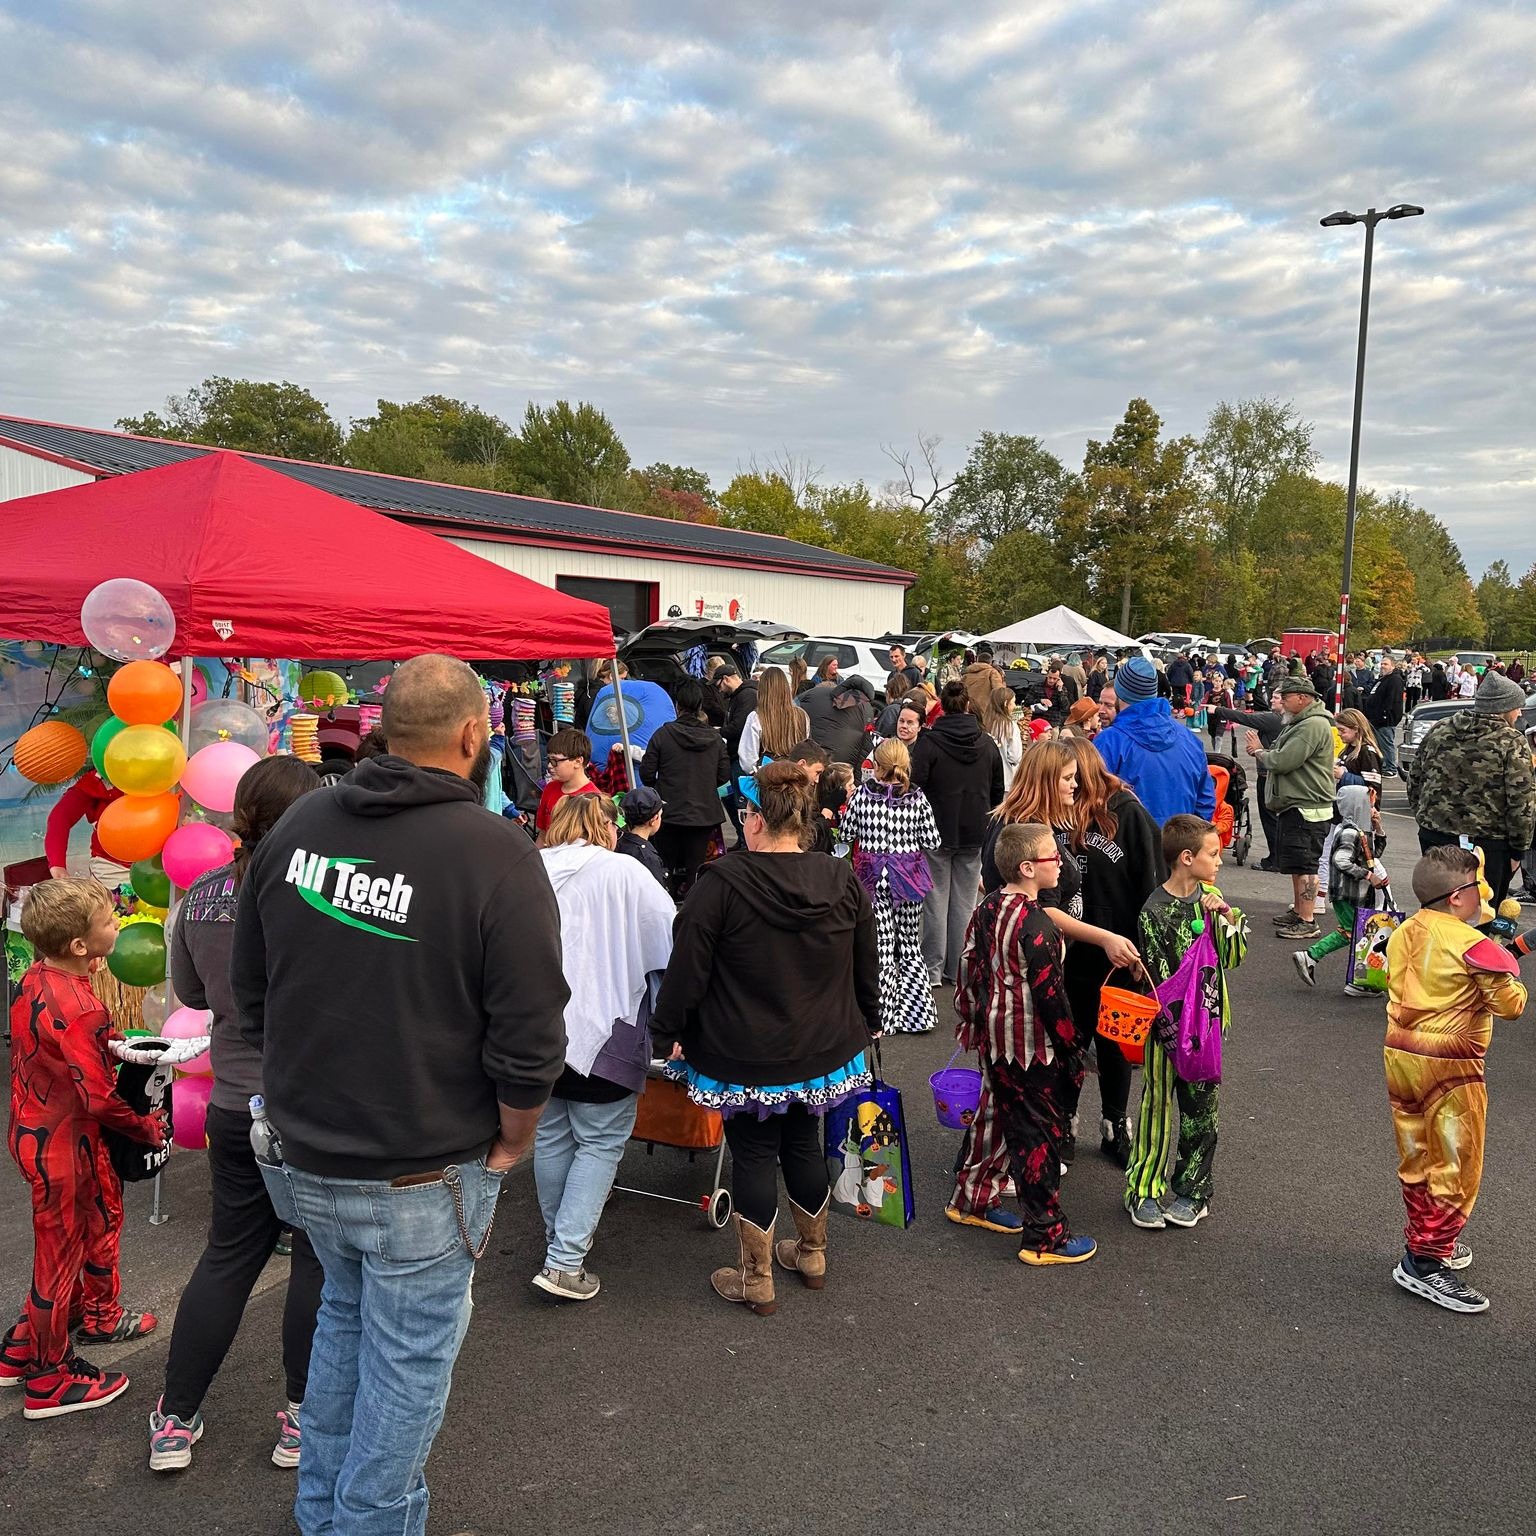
0, 632, 1536, 1533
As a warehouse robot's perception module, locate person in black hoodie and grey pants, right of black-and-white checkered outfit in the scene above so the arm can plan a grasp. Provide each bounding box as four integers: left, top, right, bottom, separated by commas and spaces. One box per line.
912, 682, 1003, 986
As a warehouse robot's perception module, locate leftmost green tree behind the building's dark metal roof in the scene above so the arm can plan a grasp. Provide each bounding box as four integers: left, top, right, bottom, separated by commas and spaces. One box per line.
117, 375, 343, 464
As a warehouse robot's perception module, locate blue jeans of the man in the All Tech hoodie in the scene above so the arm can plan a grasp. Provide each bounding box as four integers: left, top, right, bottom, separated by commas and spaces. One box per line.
263, 1160, 504, 1536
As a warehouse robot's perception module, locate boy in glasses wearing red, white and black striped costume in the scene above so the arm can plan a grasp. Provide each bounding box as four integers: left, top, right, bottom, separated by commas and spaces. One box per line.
955, 822, 1098, 1264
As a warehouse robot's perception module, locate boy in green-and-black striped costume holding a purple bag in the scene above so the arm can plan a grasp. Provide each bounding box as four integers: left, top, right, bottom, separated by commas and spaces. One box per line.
1126, 816, 1247, 1230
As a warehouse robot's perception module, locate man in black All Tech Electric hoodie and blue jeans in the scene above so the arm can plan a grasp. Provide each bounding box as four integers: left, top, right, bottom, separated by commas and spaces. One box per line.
230, 656, 570, 1536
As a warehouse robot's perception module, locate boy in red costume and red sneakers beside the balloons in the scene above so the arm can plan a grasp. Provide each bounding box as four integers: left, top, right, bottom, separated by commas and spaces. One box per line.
0, 879, 164, 1419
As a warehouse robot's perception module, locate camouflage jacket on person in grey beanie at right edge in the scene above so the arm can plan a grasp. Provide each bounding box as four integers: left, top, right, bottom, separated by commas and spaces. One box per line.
1407, 710, 1536, 857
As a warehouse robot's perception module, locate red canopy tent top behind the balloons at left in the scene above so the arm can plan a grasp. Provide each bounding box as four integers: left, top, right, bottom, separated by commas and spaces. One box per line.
0, 453, 613, 660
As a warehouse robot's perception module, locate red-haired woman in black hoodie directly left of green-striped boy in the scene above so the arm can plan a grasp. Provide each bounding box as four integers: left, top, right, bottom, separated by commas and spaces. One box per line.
1066, 737, 1167, 1167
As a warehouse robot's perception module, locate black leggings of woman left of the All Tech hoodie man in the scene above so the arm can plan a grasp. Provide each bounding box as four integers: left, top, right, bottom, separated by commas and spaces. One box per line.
163, 1104, 326, 1421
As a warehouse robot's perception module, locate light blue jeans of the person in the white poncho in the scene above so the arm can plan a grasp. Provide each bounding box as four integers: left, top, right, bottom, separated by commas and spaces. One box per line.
533, 1094, 641, 1275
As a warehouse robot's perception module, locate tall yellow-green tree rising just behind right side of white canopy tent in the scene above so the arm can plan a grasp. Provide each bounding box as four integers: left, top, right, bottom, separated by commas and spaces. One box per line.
1062, 399, 1201, 631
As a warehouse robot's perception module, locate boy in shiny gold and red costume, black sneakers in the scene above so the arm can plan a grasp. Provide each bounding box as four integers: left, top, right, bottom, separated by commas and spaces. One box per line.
1384, 845, 1525, 1312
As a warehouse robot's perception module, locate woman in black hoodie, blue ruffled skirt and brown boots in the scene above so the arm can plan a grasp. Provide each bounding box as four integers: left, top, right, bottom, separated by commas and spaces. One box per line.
651, 759, 880, 1313
